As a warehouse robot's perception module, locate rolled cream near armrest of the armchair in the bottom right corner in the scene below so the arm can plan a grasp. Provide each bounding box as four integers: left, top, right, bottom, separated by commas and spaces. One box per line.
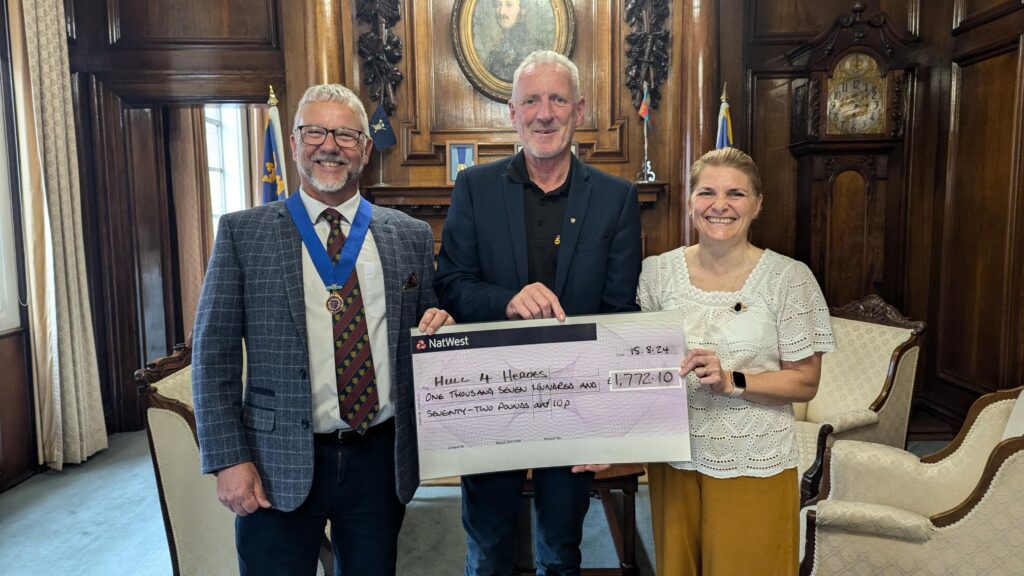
815, 500, 934, 542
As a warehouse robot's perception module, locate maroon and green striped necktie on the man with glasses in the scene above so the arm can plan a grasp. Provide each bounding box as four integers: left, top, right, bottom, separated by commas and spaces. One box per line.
321, 208, 380, 434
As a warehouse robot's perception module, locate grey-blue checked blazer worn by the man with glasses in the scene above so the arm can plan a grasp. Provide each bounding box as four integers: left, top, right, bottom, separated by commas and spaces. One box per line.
193, 195, 436, 511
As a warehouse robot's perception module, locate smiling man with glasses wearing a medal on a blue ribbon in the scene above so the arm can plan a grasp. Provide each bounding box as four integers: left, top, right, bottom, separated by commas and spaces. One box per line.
193, 84, 452, 576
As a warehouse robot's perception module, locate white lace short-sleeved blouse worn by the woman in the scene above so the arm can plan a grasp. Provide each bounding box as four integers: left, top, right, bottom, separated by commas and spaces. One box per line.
637, 248, 836, 478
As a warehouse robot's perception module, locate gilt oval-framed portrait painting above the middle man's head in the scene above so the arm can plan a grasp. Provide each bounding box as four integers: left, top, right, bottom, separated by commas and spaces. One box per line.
452, 0, 575, 102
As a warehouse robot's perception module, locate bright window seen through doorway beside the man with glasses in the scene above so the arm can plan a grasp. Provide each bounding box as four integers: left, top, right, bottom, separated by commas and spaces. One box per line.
204, 104, 248, 231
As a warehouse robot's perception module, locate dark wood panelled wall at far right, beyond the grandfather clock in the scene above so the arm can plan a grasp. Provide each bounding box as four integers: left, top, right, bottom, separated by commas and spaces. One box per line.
929, 0, 1024, 416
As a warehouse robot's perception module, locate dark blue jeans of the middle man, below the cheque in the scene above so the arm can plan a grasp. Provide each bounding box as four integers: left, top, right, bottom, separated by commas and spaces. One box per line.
462, 467, 594, 576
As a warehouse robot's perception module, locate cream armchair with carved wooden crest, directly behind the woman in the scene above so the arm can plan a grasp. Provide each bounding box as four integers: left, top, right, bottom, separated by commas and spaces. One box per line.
794, 295, 925, 501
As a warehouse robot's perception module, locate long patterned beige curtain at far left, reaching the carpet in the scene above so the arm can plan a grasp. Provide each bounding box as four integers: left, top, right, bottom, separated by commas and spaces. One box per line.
7, 0, 106, 469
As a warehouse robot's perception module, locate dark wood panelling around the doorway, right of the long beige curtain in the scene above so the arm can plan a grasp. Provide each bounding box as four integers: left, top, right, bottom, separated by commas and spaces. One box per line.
65, 0, 285, 431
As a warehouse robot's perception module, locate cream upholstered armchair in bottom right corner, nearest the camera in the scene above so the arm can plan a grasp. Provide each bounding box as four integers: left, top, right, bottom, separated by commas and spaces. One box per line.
801, 386, 1024, 576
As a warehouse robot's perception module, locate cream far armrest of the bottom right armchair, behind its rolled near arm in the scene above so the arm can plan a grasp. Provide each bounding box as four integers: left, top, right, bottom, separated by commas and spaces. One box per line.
822, 440, 959, 517
